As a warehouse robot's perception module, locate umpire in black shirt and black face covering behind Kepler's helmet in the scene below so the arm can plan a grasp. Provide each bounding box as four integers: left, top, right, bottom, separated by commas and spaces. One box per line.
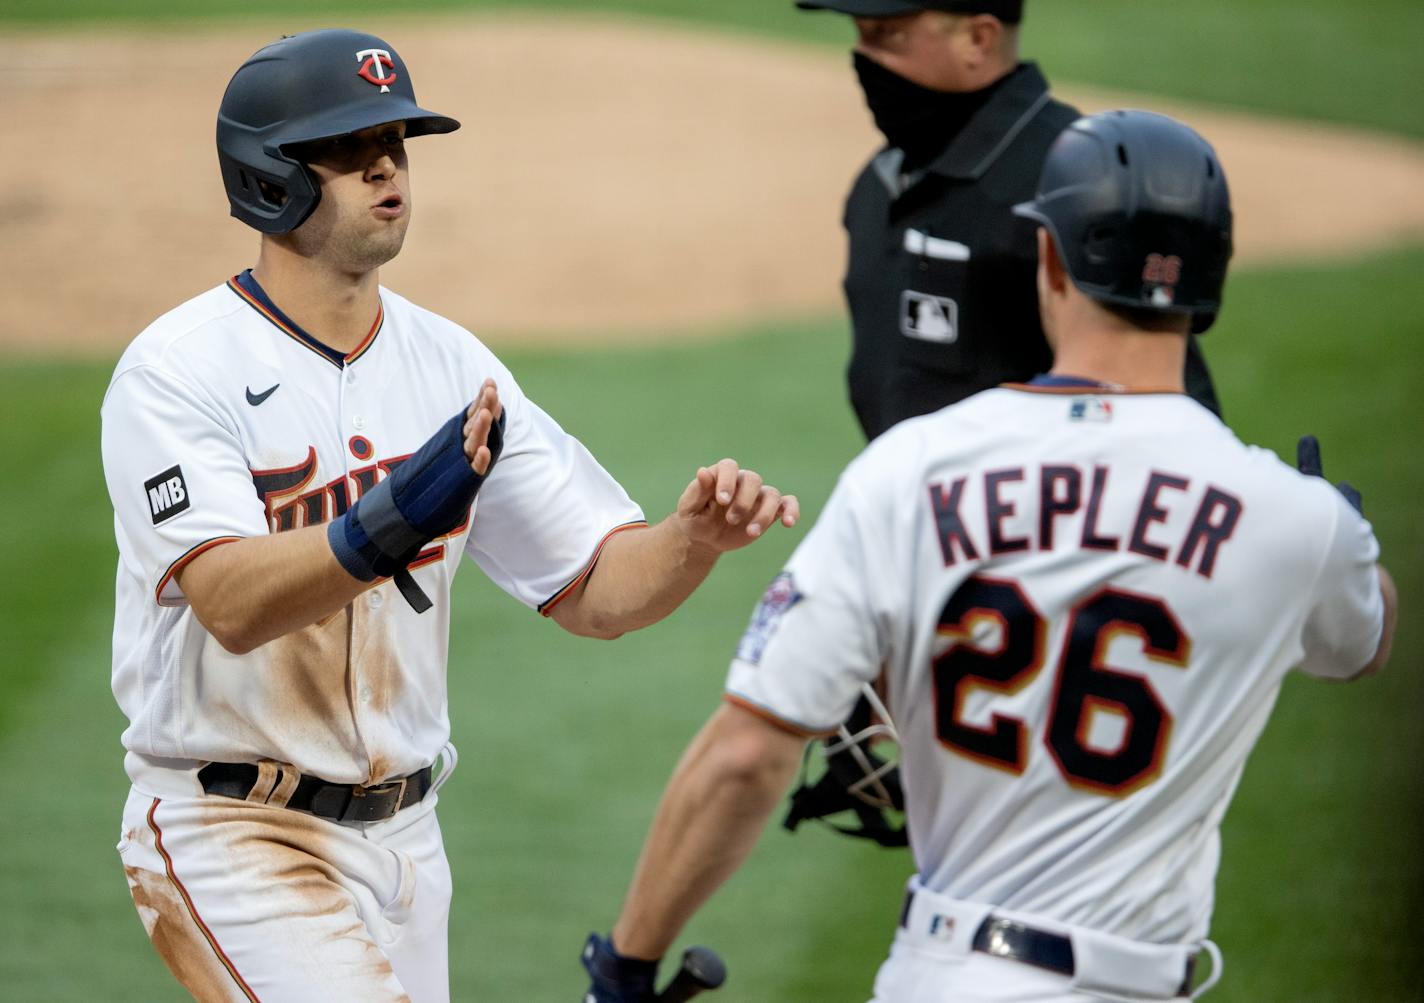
796, 0, 1219, 439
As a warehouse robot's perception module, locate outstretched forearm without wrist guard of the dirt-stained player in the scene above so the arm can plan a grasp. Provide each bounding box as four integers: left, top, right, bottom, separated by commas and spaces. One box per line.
551, 516, 718, 638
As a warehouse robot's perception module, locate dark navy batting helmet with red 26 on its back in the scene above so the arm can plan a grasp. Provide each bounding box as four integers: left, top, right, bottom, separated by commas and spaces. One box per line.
1014, 111, 1232, 332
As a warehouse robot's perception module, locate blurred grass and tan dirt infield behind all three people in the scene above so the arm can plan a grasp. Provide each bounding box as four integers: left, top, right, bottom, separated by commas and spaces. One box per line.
0, 0, 1424, 1003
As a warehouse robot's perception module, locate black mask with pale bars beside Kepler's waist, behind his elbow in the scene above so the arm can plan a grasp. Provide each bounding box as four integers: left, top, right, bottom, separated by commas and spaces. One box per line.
782, 685, 910, 846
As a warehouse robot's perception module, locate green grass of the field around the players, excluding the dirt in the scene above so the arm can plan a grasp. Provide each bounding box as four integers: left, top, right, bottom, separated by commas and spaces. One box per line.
0, 0, 1424, 1003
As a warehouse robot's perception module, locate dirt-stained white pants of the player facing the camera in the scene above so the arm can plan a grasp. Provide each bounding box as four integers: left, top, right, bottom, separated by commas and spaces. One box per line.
118, 789, 450, 1003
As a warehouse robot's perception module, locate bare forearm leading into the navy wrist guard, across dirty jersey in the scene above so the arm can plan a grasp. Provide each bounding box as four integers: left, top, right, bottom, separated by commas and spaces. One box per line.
178, 526, 375, 654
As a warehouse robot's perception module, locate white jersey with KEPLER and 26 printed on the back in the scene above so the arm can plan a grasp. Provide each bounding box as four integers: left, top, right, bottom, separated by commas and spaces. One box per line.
728, 388, 1383, 943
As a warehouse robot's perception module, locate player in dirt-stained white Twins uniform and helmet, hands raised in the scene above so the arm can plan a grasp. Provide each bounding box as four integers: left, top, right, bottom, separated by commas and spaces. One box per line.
103, 30, 796, 1003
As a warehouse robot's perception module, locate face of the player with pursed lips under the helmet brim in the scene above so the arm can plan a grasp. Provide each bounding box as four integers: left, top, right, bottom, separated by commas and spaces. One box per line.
292, 123, 412, 272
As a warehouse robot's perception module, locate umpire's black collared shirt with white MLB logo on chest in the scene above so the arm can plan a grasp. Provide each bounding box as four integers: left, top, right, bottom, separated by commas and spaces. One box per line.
844, 63, 1216, 439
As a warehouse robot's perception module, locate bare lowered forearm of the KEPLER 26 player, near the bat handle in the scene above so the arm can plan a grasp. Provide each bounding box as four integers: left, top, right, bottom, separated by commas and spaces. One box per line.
612, 705, 805, 959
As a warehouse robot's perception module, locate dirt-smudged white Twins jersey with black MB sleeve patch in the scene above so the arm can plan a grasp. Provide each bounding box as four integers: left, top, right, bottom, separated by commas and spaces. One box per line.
103, 272, 642, 794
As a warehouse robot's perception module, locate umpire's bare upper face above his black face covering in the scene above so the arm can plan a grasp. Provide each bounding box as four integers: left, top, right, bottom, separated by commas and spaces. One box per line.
854, 10, 984, 93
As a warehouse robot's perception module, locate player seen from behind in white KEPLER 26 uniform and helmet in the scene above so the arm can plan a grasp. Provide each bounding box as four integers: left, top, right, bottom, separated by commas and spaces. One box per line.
584, 113, 1396, 1003
